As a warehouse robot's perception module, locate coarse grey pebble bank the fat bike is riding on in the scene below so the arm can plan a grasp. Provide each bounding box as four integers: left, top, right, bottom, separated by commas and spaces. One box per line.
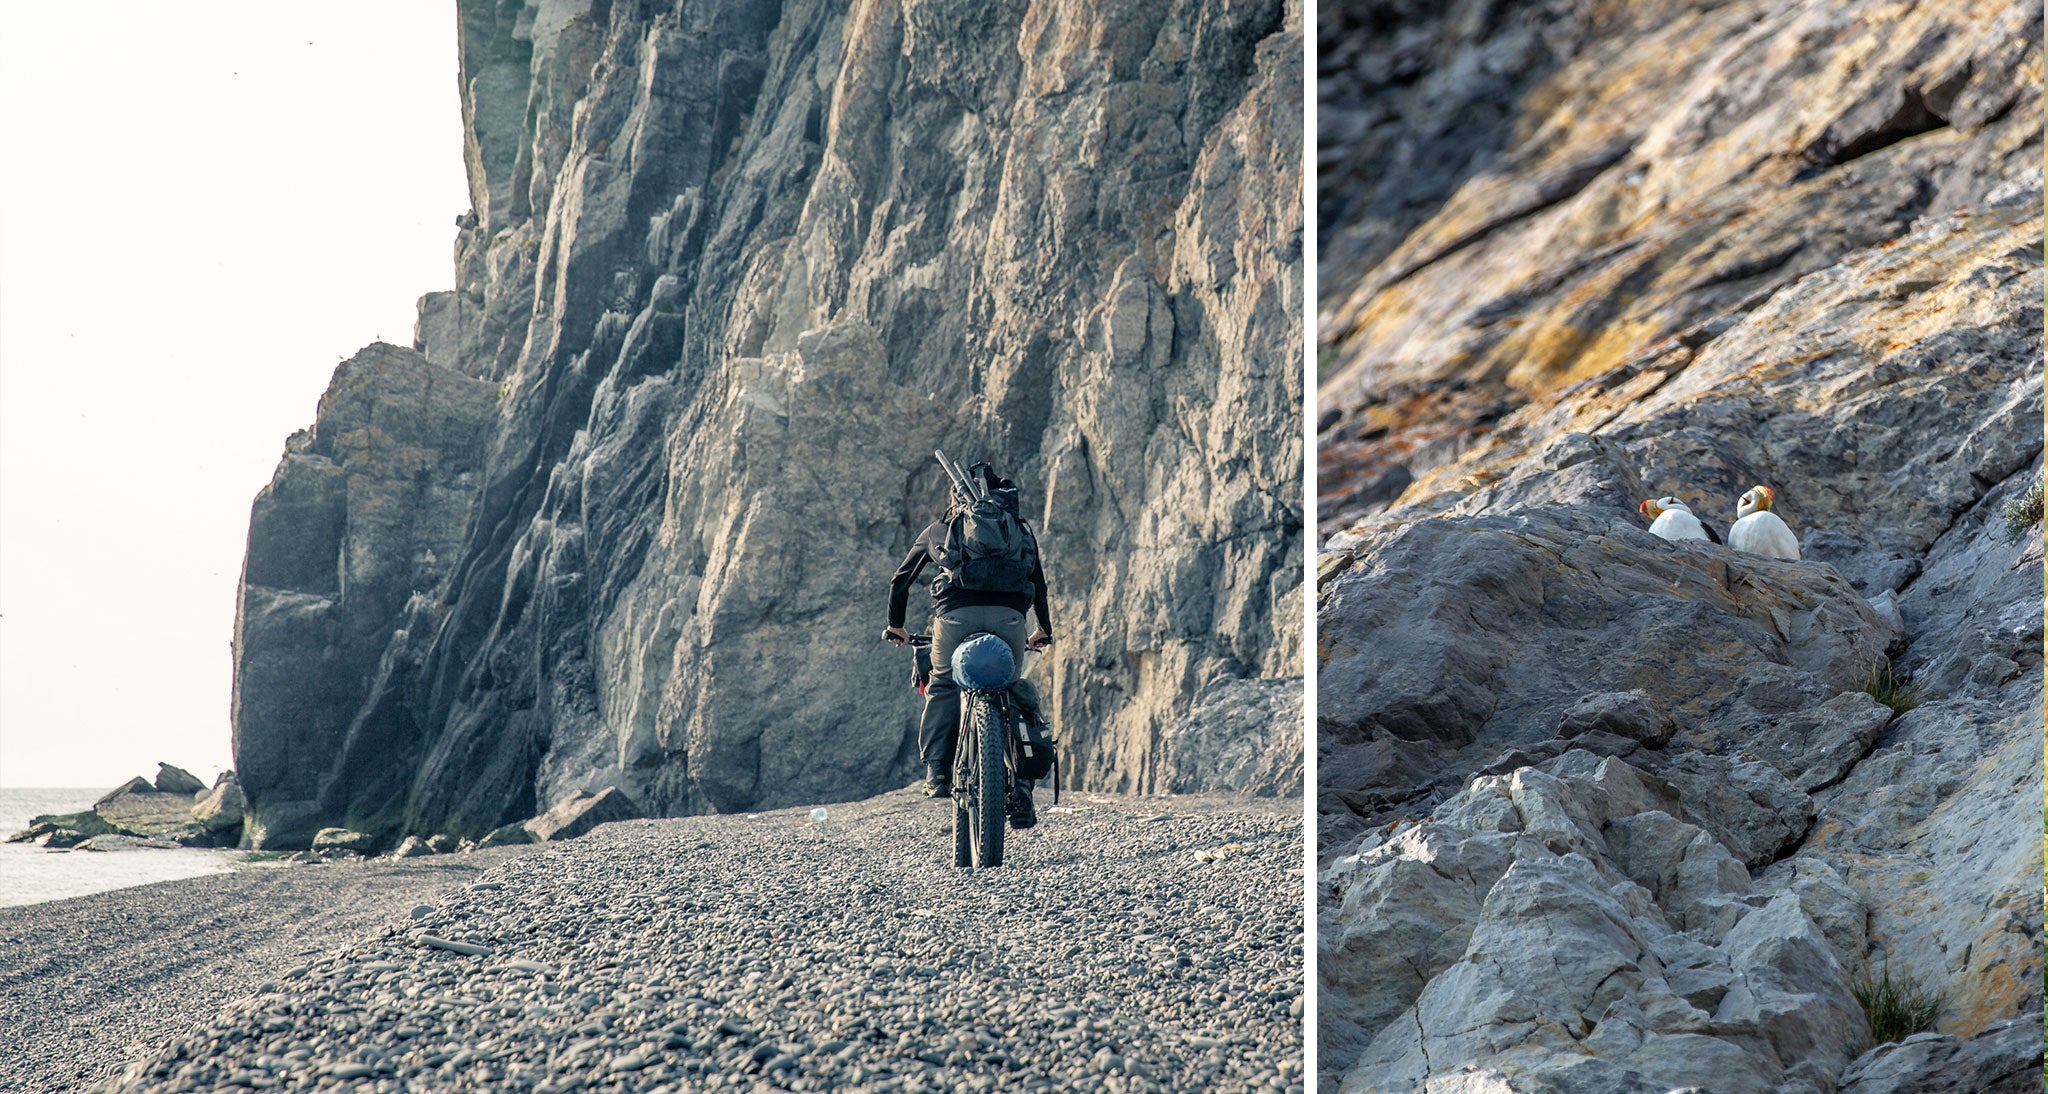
79, 791, 1303, 1092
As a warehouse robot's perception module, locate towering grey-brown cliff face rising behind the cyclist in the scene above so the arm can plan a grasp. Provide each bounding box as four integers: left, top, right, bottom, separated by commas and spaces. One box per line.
236, 0, 1303, 844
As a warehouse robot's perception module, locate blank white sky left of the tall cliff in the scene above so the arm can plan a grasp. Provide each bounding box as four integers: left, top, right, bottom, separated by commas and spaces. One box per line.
0, 0, 469, 787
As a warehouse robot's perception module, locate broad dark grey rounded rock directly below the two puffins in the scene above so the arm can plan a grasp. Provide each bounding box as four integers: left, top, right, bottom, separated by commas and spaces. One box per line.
1317, 501, 1890, 842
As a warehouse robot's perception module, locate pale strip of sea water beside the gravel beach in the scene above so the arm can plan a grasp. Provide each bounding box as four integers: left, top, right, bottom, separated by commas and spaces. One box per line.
0, 789, 233, 908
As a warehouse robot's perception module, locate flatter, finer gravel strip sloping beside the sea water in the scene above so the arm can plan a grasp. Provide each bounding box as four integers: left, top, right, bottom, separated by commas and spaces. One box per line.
0, 848, 535, 1094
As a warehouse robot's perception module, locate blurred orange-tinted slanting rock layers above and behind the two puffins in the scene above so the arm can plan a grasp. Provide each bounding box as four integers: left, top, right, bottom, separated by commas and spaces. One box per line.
1317, 0, 2042, 535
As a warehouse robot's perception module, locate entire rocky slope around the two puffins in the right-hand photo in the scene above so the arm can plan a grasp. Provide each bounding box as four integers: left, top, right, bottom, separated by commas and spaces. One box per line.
1317, 2, 2042, 1092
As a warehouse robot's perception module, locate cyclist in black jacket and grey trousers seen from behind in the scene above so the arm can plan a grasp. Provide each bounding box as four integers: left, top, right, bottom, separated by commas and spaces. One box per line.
883, 463, 1053, 828
